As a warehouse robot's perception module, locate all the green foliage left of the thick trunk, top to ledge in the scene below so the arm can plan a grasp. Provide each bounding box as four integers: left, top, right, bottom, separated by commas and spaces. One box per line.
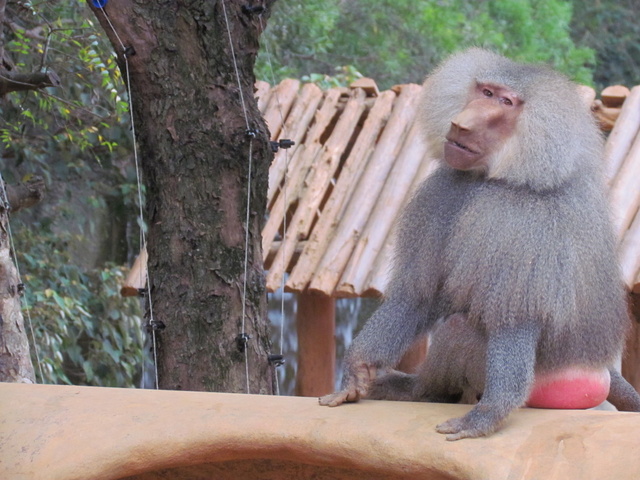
0, 0, 146, 387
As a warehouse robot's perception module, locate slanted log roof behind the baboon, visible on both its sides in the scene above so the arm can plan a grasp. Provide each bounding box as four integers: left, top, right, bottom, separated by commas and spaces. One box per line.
256, 79, 640, 297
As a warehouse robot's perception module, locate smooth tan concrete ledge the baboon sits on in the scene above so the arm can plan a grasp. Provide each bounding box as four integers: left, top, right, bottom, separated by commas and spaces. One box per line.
0, 383, 640, 480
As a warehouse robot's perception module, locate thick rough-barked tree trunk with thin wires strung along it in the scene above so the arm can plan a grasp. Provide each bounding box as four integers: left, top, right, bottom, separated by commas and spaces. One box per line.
89, 0, 273, 393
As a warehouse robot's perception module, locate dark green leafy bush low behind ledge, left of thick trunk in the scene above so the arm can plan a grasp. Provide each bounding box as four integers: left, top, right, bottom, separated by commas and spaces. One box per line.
12, 221, 145, 387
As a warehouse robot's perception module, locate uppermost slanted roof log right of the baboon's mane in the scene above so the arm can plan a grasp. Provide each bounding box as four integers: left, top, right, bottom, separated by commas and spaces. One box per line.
604, 85, 640, 181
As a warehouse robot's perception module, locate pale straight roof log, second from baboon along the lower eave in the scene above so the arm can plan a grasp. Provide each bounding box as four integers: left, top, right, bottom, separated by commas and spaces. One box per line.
336, 116, 427, 296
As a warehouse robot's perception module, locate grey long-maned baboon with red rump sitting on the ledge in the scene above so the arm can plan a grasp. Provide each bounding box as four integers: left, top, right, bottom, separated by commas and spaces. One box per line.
320, 48, 640, 440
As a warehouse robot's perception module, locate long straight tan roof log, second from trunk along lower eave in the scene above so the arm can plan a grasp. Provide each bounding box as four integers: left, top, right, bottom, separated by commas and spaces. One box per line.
286, 91, 396, 293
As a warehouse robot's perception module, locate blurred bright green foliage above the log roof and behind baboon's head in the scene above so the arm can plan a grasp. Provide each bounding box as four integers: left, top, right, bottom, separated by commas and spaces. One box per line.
257, 0, 595, 88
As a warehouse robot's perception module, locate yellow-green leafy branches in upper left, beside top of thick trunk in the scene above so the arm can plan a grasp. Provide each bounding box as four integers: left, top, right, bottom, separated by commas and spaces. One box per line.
0, 1, 131, 184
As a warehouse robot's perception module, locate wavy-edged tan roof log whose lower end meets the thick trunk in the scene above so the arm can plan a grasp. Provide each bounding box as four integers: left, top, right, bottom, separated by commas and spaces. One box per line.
262, 89, 342, 268
